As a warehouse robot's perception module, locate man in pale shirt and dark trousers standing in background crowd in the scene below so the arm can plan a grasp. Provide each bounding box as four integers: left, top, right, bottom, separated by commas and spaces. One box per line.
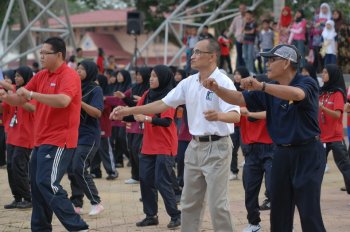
228, 3, 247, 68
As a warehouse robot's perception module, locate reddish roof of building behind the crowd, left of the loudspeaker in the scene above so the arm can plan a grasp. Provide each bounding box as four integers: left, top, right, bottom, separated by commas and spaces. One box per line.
84, 32, 131, 59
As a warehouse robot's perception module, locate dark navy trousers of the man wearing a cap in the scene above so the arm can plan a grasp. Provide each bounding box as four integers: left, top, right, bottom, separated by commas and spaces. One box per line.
270, 141, 326, 232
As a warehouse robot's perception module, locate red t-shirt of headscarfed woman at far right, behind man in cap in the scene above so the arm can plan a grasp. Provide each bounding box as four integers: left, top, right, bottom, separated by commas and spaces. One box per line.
318, 91, 344, 143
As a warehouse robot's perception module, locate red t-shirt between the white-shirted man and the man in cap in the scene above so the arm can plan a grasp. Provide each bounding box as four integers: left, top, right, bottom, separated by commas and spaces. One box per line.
240, 116, 272, 144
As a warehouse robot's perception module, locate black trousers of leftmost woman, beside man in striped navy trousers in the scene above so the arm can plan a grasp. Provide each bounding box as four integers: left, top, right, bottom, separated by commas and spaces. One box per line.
7, 144, 32, 201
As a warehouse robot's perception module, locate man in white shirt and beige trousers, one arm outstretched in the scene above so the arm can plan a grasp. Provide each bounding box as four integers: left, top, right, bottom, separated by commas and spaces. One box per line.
111, 40, 240, 232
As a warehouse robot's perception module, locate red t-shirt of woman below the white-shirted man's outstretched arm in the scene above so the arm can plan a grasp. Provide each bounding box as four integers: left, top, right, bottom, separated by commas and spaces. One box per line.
137, 91, 178, 156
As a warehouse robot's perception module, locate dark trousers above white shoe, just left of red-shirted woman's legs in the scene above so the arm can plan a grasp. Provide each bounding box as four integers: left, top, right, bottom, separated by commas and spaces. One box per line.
127, 133, 143, 180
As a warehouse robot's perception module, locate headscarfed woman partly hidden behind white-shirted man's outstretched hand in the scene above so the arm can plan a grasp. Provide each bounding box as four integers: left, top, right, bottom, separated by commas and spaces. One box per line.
106, 70, 131, 169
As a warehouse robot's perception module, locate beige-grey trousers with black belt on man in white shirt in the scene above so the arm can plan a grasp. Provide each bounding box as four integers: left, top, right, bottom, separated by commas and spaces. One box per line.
181, 136, 233, 232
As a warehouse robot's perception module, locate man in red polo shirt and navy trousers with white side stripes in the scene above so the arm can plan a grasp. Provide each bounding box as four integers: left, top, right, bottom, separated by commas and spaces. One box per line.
0, 37, 88, 231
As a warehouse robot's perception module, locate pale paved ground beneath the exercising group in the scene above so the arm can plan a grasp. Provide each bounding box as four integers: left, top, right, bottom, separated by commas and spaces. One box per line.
0, 152, 350, 232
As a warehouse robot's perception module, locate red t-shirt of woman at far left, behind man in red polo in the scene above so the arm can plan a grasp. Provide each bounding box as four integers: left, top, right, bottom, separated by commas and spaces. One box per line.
2, 100, 36, 148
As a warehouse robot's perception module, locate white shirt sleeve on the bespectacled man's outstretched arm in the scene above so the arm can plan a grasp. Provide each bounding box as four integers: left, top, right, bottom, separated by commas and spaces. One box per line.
162, 78, 190, 108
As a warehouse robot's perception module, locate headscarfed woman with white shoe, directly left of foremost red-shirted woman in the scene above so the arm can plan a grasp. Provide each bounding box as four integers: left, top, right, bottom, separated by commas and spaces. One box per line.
115, 67, 152, 184
